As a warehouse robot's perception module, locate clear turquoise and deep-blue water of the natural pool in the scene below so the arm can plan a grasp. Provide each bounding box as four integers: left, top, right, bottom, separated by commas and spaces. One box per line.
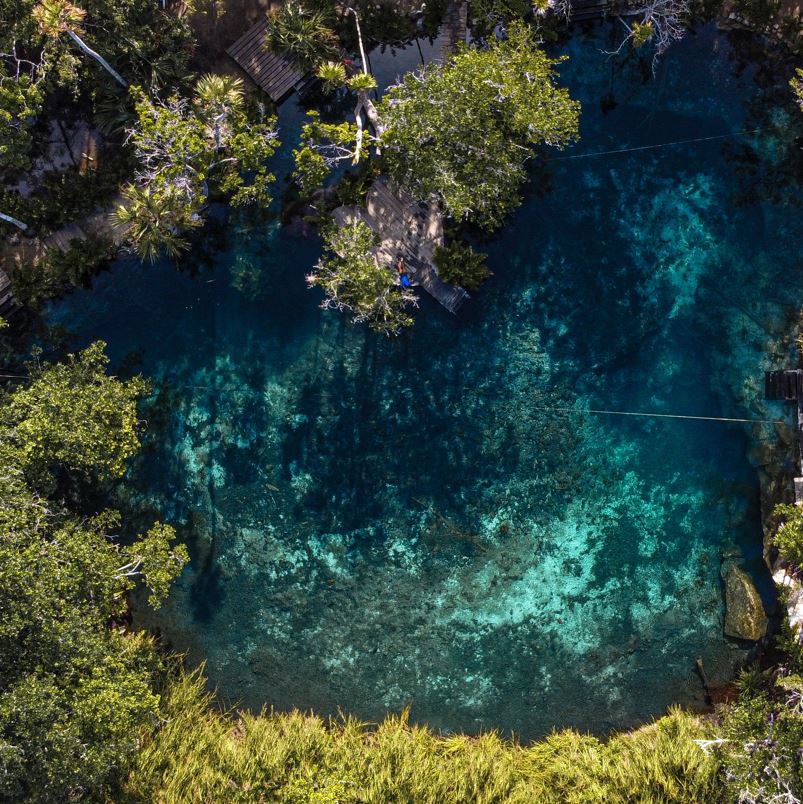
49, 29, 803, 737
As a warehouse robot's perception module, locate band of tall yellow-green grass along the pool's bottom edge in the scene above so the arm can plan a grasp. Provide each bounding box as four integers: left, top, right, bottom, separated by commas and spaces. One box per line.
123, 672, 721, 804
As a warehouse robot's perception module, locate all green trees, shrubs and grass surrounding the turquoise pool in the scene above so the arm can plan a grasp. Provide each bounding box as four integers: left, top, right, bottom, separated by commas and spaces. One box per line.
0, 0, 803, 804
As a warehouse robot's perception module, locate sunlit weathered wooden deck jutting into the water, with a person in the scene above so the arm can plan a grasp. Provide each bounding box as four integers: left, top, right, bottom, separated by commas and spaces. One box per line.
333, 178, 469, 313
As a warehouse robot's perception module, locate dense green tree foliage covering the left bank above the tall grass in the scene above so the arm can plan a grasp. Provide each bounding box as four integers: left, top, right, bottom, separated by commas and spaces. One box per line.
0, 344, 187, 804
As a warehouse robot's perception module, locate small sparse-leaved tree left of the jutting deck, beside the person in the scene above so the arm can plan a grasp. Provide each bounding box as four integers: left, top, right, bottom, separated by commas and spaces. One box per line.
307, 221, 418, 335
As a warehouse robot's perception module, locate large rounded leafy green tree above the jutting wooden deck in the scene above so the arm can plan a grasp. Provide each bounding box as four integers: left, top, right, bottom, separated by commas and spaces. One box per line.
379, 24, 579, 228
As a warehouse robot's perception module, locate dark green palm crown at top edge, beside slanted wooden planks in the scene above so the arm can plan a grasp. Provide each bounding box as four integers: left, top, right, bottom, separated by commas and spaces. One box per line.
266, 0, 338, 68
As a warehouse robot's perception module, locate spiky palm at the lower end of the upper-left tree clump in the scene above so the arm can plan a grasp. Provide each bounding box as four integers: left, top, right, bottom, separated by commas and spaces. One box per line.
111, 185, 201, 262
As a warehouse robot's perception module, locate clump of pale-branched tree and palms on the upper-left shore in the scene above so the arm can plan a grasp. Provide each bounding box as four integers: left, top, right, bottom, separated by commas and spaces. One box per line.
113, 75, 278, 260
